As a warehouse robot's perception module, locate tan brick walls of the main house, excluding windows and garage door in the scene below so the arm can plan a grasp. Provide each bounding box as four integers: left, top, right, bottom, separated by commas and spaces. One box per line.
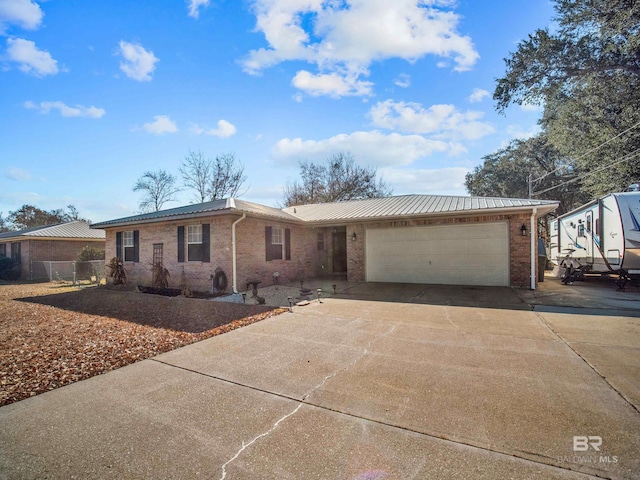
101, 214, 537, 292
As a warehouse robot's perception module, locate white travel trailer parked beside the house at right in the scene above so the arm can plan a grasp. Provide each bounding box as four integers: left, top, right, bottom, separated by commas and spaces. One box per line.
549, 192, 640, 286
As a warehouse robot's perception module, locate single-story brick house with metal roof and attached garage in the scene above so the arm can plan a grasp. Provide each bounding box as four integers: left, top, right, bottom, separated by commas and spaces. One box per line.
92, 195, 558, 291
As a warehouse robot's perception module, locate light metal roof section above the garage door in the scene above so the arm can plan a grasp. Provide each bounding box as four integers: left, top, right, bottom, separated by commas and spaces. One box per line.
283, 195, 558, 222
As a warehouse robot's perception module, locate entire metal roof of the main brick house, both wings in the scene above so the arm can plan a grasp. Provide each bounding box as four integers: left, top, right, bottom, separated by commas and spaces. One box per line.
91, 195, 558, 228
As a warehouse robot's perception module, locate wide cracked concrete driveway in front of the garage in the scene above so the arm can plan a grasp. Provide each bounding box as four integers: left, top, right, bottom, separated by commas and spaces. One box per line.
0, 284, 640, 480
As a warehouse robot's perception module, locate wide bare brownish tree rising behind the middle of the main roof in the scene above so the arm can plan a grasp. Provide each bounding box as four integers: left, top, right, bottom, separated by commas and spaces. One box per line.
283, 153, 393, 207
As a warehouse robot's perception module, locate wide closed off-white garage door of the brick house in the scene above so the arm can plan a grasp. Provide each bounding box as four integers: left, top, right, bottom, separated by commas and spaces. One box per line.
365, 222, 509, 286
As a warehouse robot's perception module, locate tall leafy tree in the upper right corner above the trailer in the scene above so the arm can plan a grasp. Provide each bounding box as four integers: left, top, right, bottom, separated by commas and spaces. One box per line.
494, 0, 640, 197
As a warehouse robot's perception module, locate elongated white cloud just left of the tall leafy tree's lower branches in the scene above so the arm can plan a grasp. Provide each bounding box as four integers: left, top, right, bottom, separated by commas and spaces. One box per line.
369, 100, 495, 140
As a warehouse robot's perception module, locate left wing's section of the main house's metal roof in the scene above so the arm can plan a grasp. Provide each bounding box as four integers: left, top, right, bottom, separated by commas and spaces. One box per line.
91, 198, 300, 228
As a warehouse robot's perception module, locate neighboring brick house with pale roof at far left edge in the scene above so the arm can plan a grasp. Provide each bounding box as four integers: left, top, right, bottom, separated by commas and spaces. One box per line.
0, 221, 105, 280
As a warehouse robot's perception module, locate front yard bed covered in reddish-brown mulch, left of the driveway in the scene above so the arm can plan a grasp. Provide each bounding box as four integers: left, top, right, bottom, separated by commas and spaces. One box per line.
0, 283, 285, 405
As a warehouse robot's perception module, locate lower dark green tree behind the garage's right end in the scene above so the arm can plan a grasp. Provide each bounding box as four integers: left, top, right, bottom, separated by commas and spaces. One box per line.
465, 134, 587, 213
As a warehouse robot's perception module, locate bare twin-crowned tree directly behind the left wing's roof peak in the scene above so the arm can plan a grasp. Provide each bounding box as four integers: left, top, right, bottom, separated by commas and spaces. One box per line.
180, 151, 247, 202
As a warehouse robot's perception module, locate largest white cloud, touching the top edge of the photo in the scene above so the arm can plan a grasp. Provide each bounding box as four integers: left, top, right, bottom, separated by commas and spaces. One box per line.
242, 0, 479, 95
